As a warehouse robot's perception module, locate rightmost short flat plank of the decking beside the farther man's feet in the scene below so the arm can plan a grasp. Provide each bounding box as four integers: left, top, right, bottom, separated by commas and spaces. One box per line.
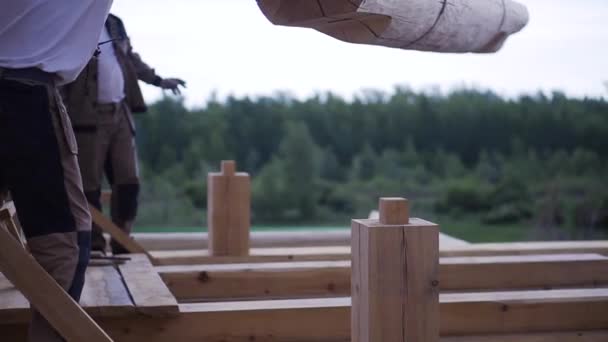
118, 254, 179, 316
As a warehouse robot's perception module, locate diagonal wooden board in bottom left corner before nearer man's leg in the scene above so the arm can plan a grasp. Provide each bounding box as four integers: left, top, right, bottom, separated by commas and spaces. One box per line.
0, 214, 112, 342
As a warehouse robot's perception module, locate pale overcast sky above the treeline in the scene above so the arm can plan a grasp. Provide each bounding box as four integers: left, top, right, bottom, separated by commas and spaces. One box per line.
113, 0, 608, 106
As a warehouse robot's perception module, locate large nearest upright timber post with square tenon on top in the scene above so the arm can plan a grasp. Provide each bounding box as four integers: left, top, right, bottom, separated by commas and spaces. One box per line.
351, 198, 439, 342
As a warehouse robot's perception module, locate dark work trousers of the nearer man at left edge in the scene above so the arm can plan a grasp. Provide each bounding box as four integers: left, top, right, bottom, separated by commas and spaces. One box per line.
0, 75, 91, 342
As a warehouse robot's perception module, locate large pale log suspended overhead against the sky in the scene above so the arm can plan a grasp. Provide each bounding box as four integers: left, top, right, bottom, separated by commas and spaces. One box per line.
257, 0, 528, 53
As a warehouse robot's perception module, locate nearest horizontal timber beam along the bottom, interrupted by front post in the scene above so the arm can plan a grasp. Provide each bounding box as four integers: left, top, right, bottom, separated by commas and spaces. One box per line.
1, 289, 608, 342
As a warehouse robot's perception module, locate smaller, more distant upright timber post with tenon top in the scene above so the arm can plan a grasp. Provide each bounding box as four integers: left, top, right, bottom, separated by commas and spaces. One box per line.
207, 161, 251, 256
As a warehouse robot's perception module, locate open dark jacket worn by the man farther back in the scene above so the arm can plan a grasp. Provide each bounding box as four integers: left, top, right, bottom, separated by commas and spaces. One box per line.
62, 14, 160, 126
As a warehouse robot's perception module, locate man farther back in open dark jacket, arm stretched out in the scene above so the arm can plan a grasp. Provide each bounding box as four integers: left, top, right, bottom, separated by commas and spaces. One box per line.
63, 15, 185, 254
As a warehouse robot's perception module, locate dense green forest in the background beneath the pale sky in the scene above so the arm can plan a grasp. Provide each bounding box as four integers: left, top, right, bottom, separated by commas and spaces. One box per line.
136, 87, 608, 241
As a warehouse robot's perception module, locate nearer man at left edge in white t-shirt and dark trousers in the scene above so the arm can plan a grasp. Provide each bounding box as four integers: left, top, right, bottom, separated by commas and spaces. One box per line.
0, 0, 111, 342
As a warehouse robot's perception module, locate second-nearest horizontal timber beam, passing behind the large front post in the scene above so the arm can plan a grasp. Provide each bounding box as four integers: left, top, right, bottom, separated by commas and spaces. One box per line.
156, 254, 608, 301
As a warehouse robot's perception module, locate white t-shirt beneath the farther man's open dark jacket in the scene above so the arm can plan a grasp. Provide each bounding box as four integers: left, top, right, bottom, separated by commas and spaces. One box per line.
97, 27, 125, 103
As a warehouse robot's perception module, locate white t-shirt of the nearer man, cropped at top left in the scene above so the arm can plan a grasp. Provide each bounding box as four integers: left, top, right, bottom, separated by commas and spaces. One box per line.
0, 0, 112, 84
